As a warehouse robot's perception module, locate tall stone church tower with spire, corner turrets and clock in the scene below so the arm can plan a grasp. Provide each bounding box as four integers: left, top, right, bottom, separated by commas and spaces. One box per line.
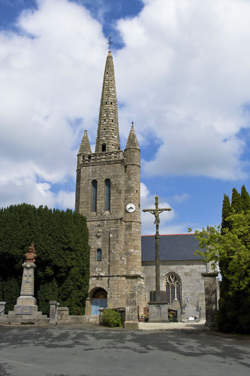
75, 51, 145, 321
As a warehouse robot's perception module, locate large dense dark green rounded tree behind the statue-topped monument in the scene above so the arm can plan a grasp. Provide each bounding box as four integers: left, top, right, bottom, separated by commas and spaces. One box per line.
0, 204, 89, 314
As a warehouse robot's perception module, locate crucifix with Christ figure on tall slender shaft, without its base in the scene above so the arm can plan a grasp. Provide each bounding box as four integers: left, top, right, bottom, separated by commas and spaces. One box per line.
143, 196, 172, 293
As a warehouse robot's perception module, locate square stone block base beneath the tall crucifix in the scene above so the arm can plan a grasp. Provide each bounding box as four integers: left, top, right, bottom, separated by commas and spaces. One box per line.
148, 291, 169, 322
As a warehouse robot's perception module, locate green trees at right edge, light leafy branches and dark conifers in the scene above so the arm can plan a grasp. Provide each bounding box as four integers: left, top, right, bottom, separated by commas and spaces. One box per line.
196, 186, 250, 333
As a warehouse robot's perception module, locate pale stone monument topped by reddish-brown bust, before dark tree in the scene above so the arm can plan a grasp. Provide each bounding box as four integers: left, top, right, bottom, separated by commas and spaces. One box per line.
8, 242, 47, 322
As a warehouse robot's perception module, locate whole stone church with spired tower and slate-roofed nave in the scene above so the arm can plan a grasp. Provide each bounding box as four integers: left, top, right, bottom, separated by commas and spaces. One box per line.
75, 51, 212, 321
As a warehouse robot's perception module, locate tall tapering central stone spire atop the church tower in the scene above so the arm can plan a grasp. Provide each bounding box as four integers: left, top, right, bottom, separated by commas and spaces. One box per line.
95, 51, 120, 153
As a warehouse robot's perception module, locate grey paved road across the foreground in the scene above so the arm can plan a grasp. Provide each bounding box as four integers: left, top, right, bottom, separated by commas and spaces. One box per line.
0, 327, 250, 376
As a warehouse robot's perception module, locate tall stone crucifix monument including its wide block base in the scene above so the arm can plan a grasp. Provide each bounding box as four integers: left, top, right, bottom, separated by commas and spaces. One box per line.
143, 196, 171, 322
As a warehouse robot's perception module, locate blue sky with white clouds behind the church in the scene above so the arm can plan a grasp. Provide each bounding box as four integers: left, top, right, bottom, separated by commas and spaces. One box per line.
0, 0, 250, 234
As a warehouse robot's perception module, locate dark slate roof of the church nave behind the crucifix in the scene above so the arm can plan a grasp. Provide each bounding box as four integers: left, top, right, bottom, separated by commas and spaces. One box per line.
141, 234, 201, 262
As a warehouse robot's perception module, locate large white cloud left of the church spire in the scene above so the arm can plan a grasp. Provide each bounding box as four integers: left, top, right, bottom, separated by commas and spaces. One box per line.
0, 0, 106, 207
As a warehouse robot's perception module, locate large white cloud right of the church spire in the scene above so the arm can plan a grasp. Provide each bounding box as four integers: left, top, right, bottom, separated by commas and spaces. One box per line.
117, 0, 250, 180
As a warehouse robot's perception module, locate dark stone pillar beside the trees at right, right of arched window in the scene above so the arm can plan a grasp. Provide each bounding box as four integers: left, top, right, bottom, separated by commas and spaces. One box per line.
202, 272, 218, 327
